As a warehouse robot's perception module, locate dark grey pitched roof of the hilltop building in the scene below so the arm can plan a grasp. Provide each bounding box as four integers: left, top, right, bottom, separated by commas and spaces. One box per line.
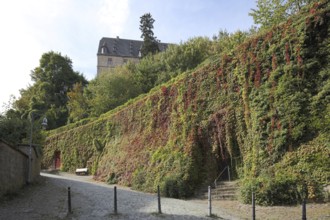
97, 37, 169, 58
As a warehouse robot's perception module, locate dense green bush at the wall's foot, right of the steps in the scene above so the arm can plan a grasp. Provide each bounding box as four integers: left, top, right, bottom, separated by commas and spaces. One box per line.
240, 139, 330, 205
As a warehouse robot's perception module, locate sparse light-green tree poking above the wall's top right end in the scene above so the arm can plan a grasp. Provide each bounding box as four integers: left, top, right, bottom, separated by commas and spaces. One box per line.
249, 0, 318, 28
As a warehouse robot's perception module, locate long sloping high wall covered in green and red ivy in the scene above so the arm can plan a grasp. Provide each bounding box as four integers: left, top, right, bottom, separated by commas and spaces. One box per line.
44, 1, 330, 204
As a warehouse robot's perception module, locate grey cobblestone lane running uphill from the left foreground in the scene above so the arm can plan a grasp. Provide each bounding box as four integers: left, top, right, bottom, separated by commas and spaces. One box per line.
0, 173, 235, 220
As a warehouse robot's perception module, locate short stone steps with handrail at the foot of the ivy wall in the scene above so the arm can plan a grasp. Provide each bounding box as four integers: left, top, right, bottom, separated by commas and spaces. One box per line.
197, 181, 238, 200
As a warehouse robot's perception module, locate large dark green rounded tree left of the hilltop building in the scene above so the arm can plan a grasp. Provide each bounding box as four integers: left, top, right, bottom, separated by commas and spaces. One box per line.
14, 51, 87, 129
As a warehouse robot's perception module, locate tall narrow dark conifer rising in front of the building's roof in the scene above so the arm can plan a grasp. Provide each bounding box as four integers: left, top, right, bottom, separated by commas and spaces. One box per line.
140, 13, 159, 57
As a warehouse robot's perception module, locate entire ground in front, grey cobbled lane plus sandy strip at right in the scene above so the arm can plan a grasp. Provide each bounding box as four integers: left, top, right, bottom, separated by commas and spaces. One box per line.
0, 173, 330, 220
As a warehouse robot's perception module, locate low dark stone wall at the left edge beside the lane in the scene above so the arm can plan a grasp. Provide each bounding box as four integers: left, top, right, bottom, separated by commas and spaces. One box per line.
0, 139, 40, 197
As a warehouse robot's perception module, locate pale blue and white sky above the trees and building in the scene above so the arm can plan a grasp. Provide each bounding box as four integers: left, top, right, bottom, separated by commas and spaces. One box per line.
0, 0, 256, 112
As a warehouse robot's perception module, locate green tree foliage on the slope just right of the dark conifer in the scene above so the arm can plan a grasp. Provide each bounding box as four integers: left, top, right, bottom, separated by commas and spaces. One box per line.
134, 37, 214, 93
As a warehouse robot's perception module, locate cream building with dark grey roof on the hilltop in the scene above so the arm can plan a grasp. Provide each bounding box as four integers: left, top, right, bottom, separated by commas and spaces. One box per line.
97, 37, 169, 74
